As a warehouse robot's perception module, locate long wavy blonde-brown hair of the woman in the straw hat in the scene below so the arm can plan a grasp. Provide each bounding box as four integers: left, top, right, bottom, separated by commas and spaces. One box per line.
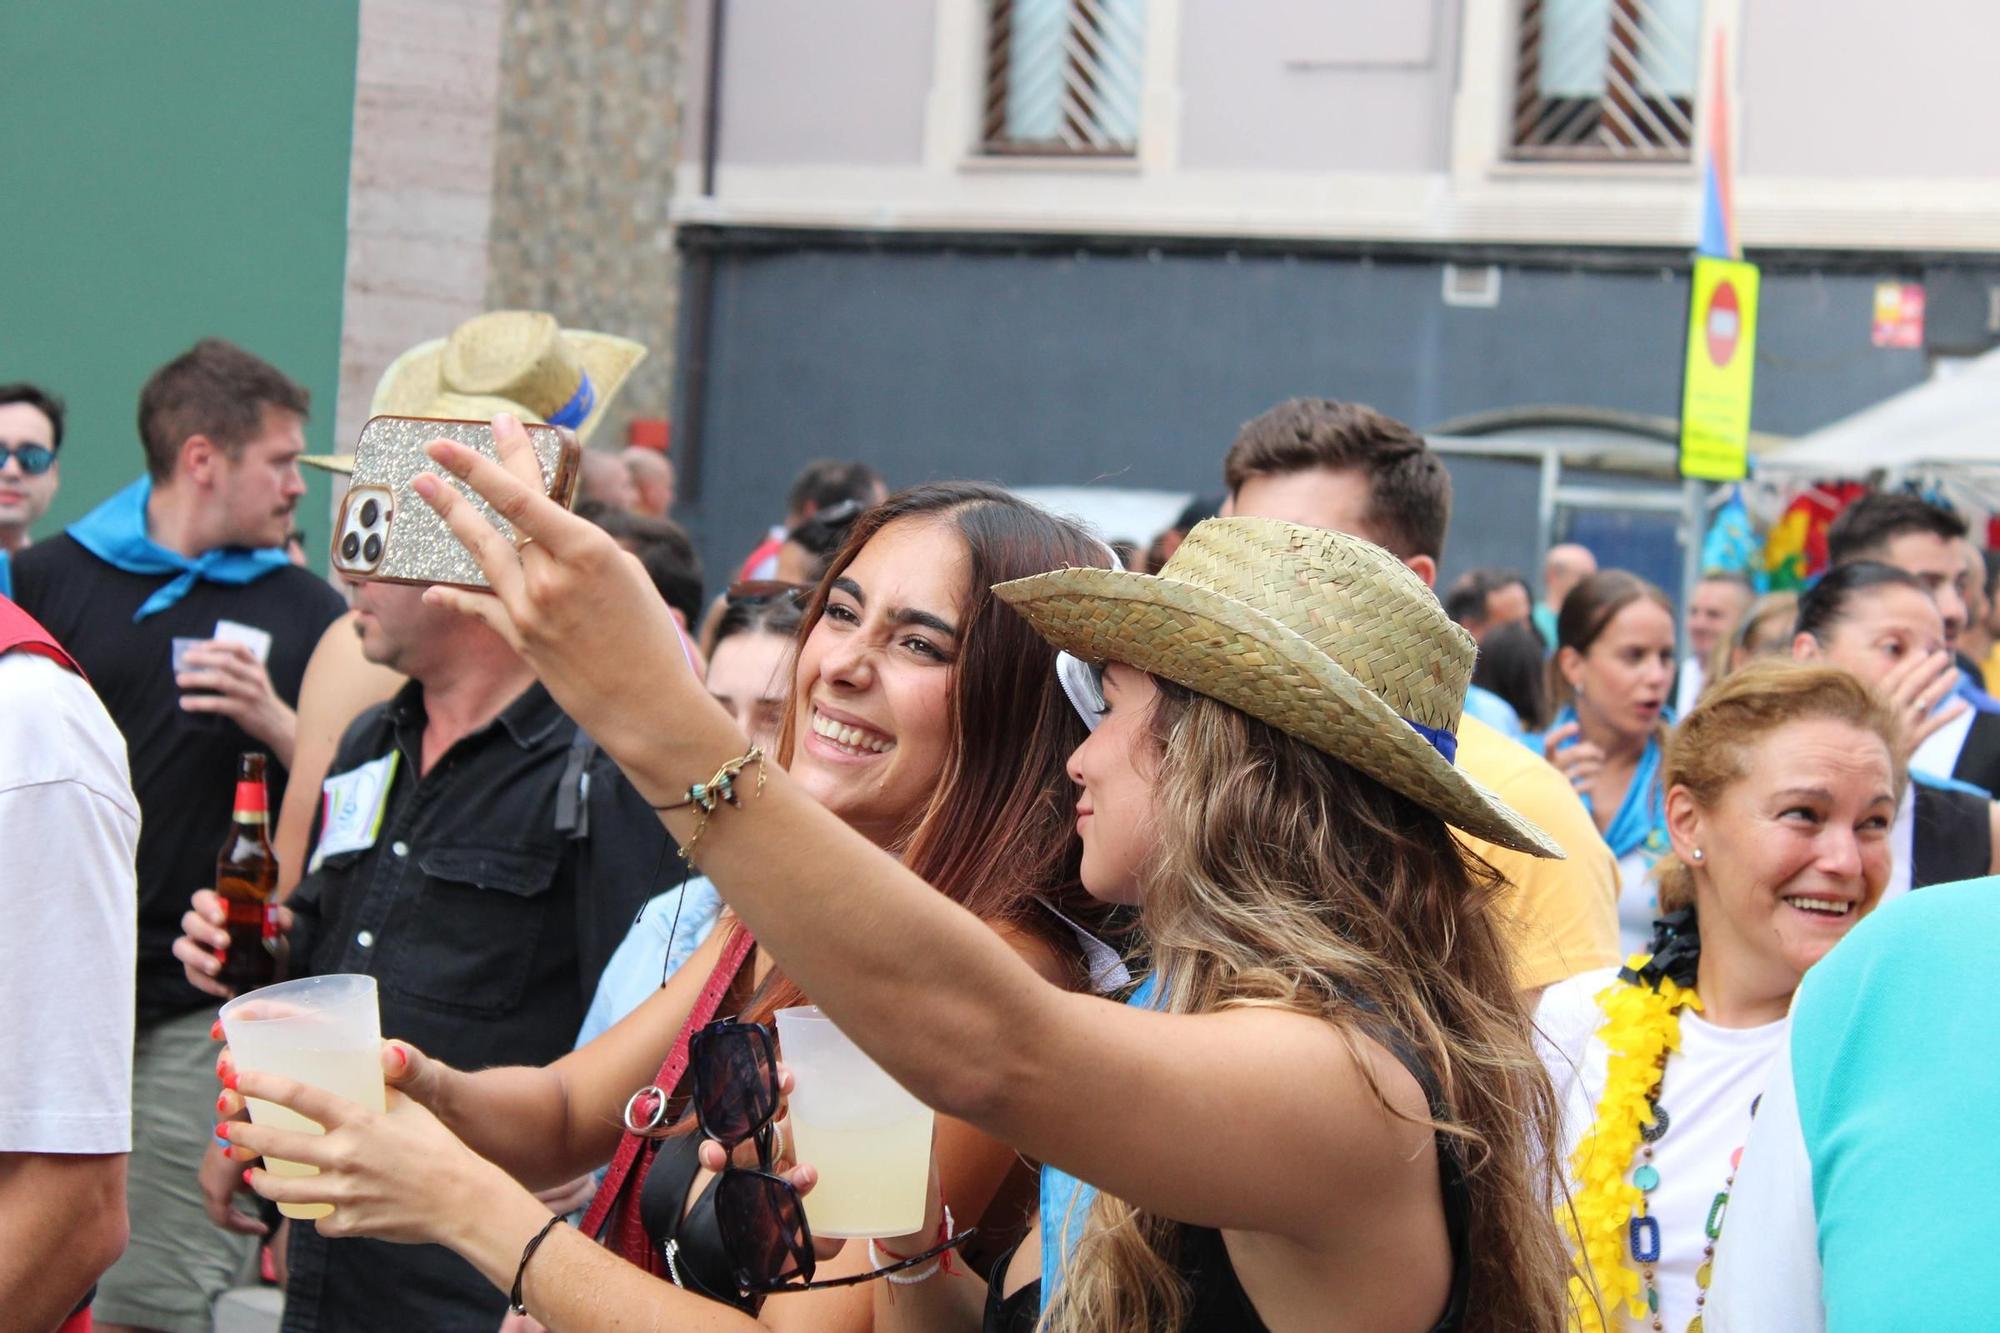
1038, 681, 1570, 1333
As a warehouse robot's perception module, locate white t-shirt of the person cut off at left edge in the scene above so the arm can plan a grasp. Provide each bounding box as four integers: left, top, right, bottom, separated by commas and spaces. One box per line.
0, 652, 138, 1153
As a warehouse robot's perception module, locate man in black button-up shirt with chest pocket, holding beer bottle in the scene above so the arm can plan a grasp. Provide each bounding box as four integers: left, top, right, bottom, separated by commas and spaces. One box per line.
176, 582, 678, 1333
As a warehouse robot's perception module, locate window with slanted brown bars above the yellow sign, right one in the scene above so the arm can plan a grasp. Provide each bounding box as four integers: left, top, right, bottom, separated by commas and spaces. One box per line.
1512, 0, 1702, 162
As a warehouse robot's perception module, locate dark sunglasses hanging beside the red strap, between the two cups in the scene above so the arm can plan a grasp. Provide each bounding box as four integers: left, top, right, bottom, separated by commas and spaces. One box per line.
688, 1023, 974, 1293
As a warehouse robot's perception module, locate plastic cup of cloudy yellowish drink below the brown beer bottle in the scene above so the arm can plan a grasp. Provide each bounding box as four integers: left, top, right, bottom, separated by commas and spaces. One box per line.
222, 973, 386, 1219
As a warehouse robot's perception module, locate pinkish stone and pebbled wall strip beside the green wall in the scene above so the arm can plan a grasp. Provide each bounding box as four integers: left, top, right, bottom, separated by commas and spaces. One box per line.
336, 0, 684, 448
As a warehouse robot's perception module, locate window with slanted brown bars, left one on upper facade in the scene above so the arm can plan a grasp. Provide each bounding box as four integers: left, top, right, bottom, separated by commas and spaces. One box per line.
982, 0, 1146, 156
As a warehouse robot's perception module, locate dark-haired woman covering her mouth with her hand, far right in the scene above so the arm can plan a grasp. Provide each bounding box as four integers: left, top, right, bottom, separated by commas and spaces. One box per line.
1792, 560, 2000, 901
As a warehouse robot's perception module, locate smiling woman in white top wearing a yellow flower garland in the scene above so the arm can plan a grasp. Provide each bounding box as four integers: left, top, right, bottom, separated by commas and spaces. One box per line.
1536, 660, 1900, 1333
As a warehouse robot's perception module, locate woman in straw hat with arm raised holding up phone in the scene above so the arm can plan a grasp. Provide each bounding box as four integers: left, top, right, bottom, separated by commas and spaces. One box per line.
211, 426, 1564, 1331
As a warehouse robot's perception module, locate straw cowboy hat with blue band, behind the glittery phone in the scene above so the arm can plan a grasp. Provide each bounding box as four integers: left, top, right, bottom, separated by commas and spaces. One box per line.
300, 310, 646, 472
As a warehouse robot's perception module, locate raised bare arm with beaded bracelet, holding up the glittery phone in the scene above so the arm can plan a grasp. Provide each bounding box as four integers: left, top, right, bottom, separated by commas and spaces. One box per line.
418, 418, 1436, 1241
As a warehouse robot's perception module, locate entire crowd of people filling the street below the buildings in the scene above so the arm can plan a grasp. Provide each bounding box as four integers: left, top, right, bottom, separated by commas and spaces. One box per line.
0, 312, 2000, 1333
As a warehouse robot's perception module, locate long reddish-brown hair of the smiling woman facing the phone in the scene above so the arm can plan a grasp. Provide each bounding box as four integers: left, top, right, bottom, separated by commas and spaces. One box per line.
748, 482, 1110, 1019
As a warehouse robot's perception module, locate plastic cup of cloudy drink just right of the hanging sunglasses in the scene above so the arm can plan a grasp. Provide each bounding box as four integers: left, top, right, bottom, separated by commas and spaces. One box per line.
778, 1007, 936, 1239
